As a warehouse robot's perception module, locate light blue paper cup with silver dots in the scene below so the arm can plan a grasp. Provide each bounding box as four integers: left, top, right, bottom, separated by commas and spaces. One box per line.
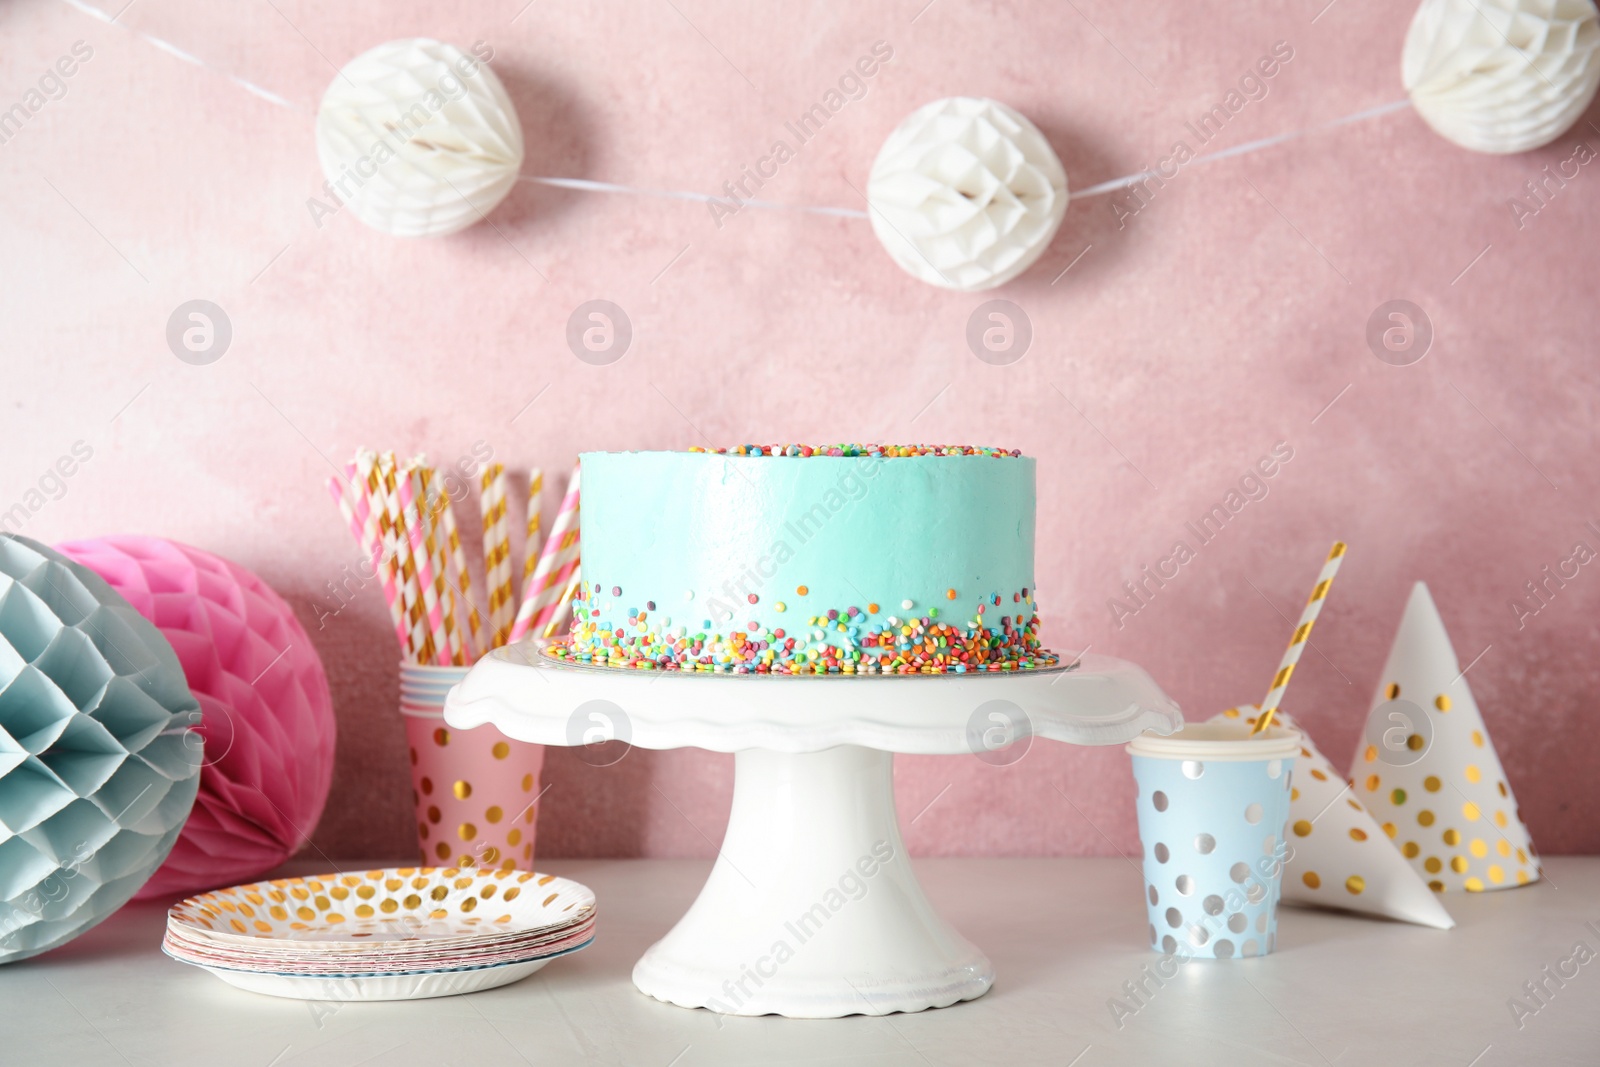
1128, 723, 1299, 960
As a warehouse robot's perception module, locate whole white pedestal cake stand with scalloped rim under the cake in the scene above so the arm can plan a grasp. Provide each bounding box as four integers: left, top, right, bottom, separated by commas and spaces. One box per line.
445, 641, 1182, 1019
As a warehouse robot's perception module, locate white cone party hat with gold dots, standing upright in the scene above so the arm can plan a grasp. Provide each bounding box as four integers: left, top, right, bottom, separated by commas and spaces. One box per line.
1350, 582, 1539, 893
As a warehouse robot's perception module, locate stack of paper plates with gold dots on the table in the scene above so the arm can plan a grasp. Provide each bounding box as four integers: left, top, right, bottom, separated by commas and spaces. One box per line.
162, 867, 595, 1000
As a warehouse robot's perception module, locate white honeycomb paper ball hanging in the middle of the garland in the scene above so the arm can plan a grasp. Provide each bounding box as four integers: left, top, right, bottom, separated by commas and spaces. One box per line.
867, 96, 1067, 293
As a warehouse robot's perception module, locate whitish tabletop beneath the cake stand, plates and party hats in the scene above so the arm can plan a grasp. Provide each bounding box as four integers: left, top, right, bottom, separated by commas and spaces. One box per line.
0, 857, 1600, 1067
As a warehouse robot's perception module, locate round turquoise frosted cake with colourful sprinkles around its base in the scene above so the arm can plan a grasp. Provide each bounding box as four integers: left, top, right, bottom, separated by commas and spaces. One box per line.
547, 445, 1056, 673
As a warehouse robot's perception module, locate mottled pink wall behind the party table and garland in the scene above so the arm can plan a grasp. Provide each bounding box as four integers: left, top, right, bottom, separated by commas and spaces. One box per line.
0, 0, 1600, 856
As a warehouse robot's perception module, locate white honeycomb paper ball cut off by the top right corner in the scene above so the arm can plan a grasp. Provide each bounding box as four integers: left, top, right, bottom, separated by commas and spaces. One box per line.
1400, 0, 1600, 154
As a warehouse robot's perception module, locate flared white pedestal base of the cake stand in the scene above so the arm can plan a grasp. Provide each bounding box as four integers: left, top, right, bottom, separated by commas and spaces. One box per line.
634, 745, 994, 1019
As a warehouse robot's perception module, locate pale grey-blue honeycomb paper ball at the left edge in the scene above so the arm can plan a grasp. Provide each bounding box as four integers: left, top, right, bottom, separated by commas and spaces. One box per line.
0, 534, 200, 963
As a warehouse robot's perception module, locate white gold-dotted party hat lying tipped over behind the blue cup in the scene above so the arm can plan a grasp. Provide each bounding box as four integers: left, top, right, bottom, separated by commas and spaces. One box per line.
1213, 704, 1456, 929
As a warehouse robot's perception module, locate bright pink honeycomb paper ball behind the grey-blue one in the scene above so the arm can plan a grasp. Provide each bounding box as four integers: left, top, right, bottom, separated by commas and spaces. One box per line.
59, 536, 334, 899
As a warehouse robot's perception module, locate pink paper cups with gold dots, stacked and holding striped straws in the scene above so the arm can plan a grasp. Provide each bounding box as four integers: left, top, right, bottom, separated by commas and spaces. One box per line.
400, 664, 544, 870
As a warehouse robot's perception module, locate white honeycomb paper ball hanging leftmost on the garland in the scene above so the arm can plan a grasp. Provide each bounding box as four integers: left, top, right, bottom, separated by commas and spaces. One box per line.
317, 37, 523, 237
